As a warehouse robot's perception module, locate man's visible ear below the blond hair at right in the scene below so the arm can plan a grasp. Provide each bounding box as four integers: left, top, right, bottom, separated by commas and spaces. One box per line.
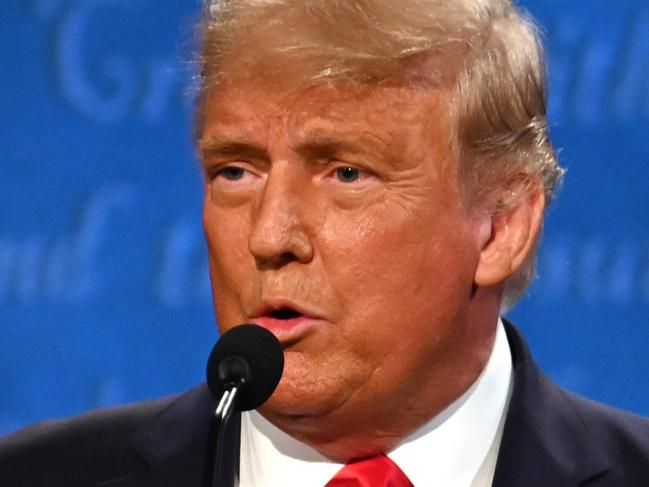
474, 188, 545, 287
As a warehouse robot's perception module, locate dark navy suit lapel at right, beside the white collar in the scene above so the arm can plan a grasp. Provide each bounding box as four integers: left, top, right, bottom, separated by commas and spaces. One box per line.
493, 323, 608, 487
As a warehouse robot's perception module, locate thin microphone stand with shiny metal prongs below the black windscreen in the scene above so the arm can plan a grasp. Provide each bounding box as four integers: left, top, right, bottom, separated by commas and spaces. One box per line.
207, 383, 240, 487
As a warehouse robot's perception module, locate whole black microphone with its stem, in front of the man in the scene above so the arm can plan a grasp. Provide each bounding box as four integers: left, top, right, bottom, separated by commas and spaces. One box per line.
206, 324, 284, 487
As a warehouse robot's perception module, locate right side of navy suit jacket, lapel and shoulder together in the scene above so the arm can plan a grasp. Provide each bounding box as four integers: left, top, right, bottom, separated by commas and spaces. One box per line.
494, 323, 649, 487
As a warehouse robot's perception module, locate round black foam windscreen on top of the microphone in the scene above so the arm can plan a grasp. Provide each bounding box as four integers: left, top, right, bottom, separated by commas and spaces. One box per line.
207, 324, 284, 411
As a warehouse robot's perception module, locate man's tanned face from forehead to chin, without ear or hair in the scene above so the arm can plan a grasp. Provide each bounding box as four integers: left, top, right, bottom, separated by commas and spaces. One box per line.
201, 74, 492, 456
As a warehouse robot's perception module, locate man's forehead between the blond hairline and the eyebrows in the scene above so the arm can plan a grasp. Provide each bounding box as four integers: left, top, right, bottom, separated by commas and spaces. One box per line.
204, 77, 450, 158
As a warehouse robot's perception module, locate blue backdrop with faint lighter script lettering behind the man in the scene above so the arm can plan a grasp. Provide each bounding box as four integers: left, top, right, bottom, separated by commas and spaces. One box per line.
0, 0, 649, 433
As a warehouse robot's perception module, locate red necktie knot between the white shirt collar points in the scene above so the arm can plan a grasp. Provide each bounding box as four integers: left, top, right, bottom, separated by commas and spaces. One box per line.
325, 454, 414, 487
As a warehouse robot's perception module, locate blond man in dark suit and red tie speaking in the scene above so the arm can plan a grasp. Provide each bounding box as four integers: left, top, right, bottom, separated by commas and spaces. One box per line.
0, 0, 649, 487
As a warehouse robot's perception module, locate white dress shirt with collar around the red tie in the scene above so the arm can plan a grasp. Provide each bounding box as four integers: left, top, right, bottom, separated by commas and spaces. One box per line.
239, 322, 512, 487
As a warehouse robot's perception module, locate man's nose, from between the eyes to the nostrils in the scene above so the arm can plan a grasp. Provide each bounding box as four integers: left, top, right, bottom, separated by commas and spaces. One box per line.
248, 166, 313, 269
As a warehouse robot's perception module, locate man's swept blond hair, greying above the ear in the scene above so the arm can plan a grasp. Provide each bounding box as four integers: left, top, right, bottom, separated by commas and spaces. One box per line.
198, 0, 563, 308
